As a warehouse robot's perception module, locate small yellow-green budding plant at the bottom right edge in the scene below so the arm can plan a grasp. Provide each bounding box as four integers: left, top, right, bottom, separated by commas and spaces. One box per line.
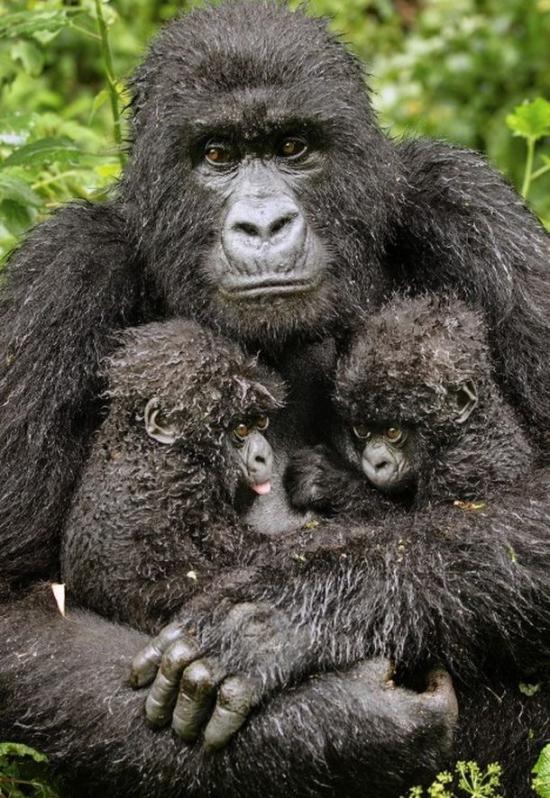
407, 762, 502, 798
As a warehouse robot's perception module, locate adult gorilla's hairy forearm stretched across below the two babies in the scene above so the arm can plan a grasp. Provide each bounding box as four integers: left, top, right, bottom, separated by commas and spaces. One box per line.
134, 471, 550, 772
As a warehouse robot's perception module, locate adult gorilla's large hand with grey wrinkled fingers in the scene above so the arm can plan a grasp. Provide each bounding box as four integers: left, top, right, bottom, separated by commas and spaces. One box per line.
130, 603, 307, 750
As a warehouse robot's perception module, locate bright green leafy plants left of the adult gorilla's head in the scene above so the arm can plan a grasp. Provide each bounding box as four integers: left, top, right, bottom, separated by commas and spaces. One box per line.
0, 0, 124, 262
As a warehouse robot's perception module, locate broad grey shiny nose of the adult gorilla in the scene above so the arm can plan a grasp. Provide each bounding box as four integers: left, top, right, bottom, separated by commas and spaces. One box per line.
222, 197, 306, 267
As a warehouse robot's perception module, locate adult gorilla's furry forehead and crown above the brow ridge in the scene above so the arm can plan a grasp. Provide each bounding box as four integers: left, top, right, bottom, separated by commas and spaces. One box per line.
134, 2, 374, 129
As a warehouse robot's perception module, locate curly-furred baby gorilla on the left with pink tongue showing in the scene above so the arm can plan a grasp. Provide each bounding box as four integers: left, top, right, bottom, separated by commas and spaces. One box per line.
62, 320, 284, 631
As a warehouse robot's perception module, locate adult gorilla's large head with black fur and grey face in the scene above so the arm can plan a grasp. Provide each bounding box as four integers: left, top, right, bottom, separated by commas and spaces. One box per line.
123, 0, 395, 347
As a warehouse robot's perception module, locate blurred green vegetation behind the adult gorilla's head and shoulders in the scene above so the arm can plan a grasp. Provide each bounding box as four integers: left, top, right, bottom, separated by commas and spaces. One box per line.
0, 0, 550, 259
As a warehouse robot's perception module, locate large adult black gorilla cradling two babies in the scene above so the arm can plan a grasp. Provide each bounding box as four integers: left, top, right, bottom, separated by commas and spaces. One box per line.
0, 2, 550, 798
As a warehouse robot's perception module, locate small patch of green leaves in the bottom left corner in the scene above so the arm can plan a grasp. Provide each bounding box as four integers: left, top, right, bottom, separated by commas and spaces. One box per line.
0, 743, 59, 798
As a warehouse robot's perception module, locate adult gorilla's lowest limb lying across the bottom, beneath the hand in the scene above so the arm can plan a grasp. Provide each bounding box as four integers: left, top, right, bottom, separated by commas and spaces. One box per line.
0, 587, 456, 798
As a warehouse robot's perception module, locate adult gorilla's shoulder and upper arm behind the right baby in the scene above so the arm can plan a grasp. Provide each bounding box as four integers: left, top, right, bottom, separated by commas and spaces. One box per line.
394, 140, 550, 454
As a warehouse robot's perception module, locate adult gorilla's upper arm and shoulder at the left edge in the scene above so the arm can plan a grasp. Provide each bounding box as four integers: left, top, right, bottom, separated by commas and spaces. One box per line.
0, 204, 138, 580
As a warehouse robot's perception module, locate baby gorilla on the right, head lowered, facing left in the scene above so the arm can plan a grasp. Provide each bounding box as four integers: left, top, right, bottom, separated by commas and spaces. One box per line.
286, 296, 533, 517
